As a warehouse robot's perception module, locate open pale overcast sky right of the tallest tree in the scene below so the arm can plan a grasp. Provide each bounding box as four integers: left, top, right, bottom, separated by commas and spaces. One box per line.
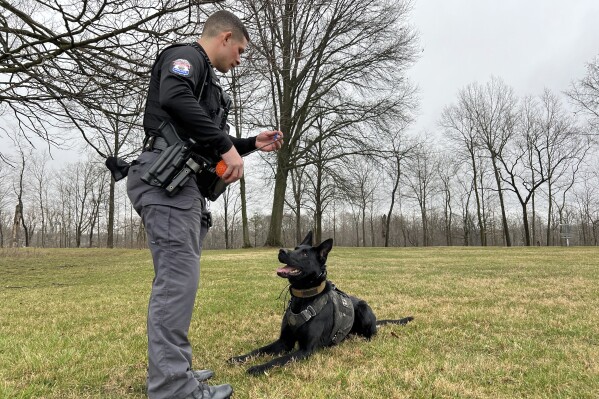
409, 0, 599, 133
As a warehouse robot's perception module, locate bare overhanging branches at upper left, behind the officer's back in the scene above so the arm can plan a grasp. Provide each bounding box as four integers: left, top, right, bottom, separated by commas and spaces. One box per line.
0, 0, 218, 150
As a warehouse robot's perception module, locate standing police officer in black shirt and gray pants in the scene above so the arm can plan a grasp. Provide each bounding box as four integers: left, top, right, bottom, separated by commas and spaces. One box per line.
127, 11, 282, 399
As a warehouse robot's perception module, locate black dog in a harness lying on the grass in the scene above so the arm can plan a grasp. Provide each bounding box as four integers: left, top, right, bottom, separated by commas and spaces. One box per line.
229, 232, 413, 375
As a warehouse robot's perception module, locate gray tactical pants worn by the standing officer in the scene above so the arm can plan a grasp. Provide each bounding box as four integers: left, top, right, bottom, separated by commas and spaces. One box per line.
127, 152, 209, 399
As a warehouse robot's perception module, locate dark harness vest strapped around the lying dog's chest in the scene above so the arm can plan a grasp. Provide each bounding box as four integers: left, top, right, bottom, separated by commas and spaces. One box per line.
285, 284, 354, 345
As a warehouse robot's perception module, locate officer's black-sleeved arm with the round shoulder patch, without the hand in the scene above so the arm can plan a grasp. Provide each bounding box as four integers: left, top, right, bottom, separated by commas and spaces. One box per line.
159, 46, 233, 154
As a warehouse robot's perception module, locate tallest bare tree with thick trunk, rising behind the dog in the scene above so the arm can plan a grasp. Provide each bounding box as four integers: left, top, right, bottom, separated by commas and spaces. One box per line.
242, 0, 416, 246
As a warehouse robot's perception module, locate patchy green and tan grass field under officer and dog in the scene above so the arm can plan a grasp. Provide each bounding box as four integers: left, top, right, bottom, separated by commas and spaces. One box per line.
0, 247, 599, 399
